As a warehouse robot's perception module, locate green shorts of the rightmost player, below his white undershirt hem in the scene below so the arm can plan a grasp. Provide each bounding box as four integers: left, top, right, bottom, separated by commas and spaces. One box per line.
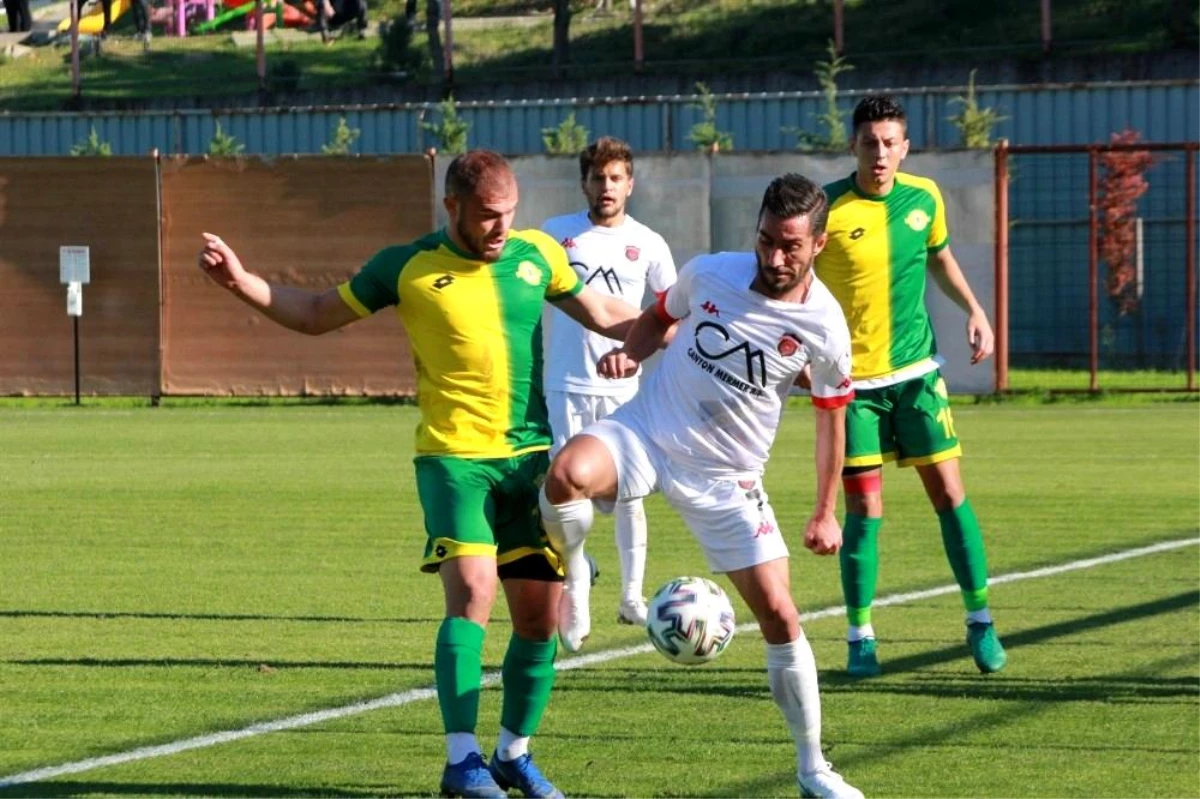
846, 370, 962, 467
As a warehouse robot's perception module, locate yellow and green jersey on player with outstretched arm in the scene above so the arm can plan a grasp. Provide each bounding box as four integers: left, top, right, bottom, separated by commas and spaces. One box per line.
338, 230, 583, 458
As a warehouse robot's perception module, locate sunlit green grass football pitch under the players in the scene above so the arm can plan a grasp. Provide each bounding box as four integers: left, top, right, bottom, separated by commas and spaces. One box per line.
0, 403, 1200, 799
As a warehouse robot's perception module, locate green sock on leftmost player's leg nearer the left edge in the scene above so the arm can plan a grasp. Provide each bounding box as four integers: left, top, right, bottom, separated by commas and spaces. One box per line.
433, 617, 484, 733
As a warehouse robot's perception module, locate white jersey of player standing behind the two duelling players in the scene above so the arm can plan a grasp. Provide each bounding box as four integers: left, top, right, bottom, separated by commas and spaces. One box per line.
541, 211, 676, 396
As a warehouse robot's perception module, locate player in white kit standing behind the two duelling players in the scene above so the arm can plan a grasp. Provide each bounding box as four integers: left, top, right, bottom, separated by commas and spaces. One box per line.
542, 137, 676, 638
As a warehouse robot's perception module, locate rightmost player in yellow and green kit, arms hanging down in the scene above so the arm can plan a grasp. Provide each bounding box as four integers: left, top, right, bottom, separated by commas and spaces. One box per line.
816, 96, 1006, 677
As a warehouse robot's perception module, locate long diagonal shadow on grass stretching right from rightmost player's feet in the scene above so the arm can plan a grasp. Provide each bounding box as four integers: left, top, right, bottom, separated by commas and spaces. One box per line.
821, 590, 1200, 698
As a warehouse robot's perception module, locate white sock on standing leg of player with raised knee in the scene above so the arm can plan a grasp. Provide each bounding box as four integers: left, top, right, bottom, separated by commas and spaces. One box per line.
767, 632, 826, 774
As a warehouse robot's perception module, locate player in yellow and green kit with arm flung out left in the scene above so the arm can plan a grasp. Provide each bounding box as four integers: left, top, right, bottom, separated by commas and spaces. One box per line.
199, 150, 638, 799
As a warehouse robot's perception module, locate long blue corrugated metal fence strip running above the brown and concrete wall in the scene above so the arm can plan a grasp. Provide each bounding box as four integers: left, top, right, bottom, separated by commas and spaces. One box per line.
0, 80, 1200, 156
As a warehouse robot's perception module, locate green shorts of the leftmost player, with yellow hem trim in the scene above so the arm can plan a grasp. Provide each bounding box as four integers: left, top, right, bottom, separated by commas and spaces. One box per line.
413, 450, 563, 577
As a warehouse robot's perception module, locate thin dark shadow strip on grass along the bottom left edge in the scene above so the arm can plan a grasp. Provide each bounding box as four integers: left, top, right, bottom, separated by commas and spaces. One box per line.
0, 781, 437, 799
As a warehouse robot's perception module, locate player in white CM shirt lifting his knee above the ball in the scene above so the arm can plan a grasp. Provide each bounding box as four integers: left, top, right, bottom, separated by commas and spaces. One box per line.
541, 174, 863, 799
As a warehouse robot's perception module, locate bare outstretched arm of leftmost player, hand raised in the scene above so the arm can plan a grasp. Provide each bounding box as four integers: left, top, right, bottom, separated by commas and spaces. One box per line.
198, 233, 359, 336
